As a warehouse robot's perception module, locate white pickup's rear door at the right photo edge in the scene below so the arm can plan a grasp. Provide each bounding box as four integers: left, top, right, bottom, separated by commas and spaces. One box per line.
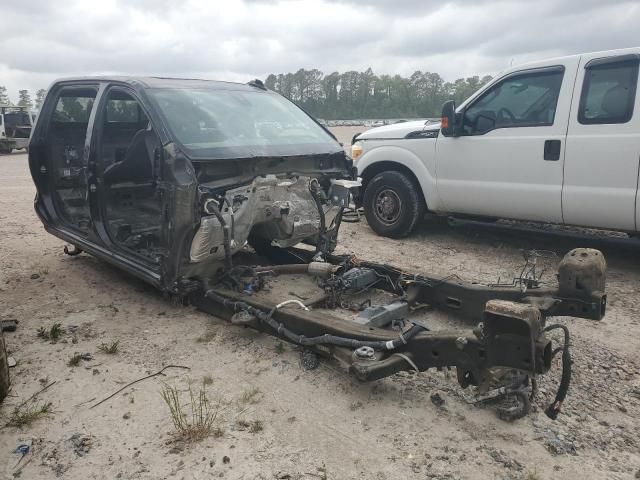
562, 49, 640, 231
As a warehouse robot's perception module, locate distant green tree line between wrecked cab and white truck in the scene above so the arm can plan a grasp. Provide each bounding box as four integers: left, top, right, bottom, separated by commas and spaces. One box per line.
264, 68, 491, 120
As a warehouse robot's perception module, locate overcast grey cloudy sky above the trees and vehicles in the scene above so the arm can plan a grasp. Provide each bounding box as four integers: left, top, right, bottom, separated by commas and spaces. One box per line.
0, 0, 640, 101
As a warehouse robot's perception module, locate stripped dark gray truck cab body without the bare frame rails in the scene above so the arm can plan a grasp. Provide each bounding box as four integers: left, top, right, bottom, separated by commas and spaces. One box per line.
29, 78, 353, 294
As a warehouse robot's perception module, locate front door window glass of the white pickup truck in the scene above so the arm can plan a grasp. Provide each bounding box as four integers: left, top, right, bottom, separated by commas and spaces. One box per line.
463, 67, 564, 135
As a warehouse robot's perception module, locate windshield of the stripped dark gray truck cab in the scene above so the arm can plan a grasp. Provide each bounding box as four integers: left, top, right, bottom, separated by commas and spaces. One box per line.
149, 89, 341, 158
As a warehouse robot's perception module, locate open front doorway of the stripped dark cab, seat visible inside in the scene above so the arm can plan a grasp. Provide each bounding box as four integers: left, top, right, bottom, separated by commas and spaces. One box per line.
94, 87, 165, 265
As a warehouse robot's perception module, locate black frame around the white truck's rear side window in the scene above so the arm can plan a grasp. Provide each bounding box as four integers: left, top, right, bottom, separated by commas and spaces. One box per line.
578, 54, 640, 125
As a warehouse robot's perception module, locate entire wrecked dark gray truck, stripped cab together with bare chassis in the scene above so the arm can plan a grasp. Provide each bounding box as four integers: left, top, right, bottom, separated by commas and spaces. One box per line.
29, 78, 606, 419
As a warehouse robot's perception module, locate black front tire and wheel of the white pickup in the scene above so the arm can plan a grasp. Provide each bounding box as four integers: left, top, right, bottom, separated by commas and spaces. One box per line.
362, 171, 426, 238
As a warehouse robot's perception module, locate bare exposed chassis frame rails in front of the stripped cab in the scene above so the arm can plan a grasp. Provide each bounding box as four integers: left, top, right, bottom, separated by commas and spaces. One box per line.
191, 249, 606, 418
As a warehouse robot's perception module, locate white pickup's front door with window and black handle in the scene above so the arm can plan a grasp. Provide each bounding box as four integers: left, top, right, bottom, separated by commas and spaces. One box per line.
436, 57, 579, 222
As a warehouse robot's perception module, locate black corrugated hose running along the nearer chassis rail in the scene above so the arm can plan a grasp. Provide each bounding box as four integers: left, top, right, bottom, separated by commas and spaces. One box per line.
205, 289, 423, 351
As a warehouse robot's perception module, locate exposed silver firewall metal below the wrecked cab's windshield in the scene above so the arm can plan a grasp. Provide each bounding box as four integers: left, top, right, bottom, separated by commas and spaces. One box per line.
190, 175, 359, 263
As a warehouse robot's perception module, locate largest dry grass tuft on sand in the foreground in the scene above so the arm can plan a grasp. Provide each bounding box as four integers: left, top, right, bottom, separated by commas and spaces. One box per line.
162, 383, 224, 442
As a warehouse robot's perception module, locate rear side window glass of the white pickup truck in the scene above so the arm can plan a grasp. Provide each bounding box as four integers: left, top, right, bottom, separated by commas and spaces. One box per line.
578, 59, 638, 125
